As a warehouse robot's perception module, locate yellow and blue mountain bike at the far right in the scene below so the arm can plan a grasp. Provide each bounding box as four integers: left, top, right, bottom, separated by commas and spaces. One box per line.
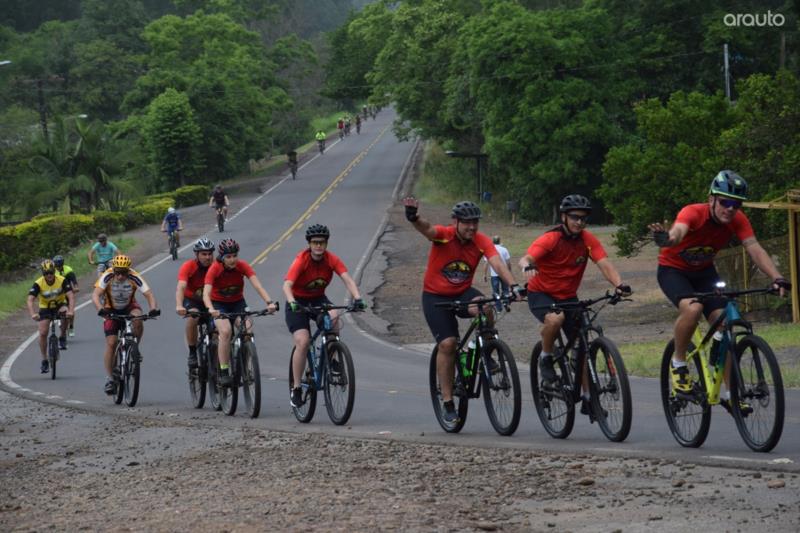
661, 283, 785, 452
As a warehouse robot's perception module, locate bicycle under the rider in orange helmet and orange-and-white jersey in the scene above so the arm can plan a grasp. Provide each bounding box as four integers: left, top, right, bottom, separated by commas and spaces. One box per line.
105, 312, 158, 407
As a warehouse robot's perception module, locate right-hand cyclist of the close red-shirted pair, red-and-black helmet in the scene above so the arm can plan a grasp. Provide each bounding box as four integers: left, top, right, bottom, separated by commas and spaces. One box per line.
203, 239, 276, 387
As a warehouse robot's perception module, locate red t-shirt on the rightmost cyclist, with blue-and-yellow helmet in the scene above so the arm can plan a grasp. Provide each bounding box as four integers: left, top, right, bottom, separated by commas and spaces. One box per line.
658, 204, 755, 271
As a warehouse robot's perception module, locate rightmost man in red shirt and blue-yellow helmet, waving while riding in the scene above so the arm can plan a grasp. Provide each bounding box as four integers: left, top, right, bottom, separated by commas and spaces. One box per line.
648, 170, 791, 411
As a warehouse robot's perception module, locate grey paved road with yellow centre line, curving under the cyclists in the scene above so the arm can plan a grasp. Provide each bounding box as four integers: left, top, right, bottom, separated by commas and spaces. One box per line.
0, 111, 800, 471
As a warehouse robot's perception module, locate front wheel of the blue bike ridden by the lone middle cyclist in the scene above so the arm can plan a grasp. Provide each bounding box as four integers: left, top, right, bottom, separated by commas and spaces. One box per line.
324, 341, 356, 426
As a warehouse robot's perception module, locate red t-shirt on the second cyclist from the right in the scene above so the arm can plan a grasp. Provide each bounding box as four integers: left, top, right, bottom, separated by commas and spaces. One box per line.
527, 226, 608, 300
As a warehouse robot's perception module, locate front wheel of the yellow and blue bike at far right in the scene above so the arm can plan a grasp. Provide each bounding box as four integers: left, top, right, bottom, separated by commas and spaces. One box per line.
731, 335, 785, 452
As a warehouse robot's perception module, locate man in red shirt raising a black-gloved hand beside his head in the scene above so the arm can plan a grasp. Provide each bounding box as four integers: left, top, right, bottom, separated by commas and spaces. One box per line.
403, 197, 520, 423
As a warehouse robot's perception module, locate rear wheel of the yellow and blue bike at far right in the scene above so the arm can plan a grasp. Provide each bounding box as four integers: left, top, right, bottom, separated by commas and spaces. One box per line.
661, 339, 711, 448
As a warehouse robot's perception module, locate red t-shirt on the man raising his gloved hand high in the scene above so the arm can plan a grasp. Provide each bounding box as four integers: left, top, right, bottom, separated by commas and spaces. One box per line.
422, 225, 497, 296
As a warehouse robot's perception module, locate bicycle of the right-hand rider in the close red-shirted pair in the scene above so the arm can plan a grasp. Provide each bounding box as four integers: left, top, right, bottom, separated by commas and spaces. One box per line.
214, 308, 278, 418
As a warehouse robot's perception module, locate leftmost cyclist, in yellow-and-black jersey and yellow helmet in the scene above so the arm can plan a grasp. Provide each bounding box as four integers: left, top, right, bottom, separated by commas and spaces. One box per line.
27, 259, 75, 374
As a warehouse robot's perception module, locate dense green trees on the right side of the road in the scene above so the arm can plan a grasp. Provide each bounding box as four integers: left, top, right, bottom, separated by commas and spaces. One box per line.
326, 0, 800, 253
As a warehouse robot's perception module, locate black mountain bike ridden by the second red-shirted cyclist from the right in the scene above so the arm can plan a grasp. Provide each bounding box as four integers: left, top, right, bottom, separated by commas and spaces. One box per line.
530, 293, 633, 442
